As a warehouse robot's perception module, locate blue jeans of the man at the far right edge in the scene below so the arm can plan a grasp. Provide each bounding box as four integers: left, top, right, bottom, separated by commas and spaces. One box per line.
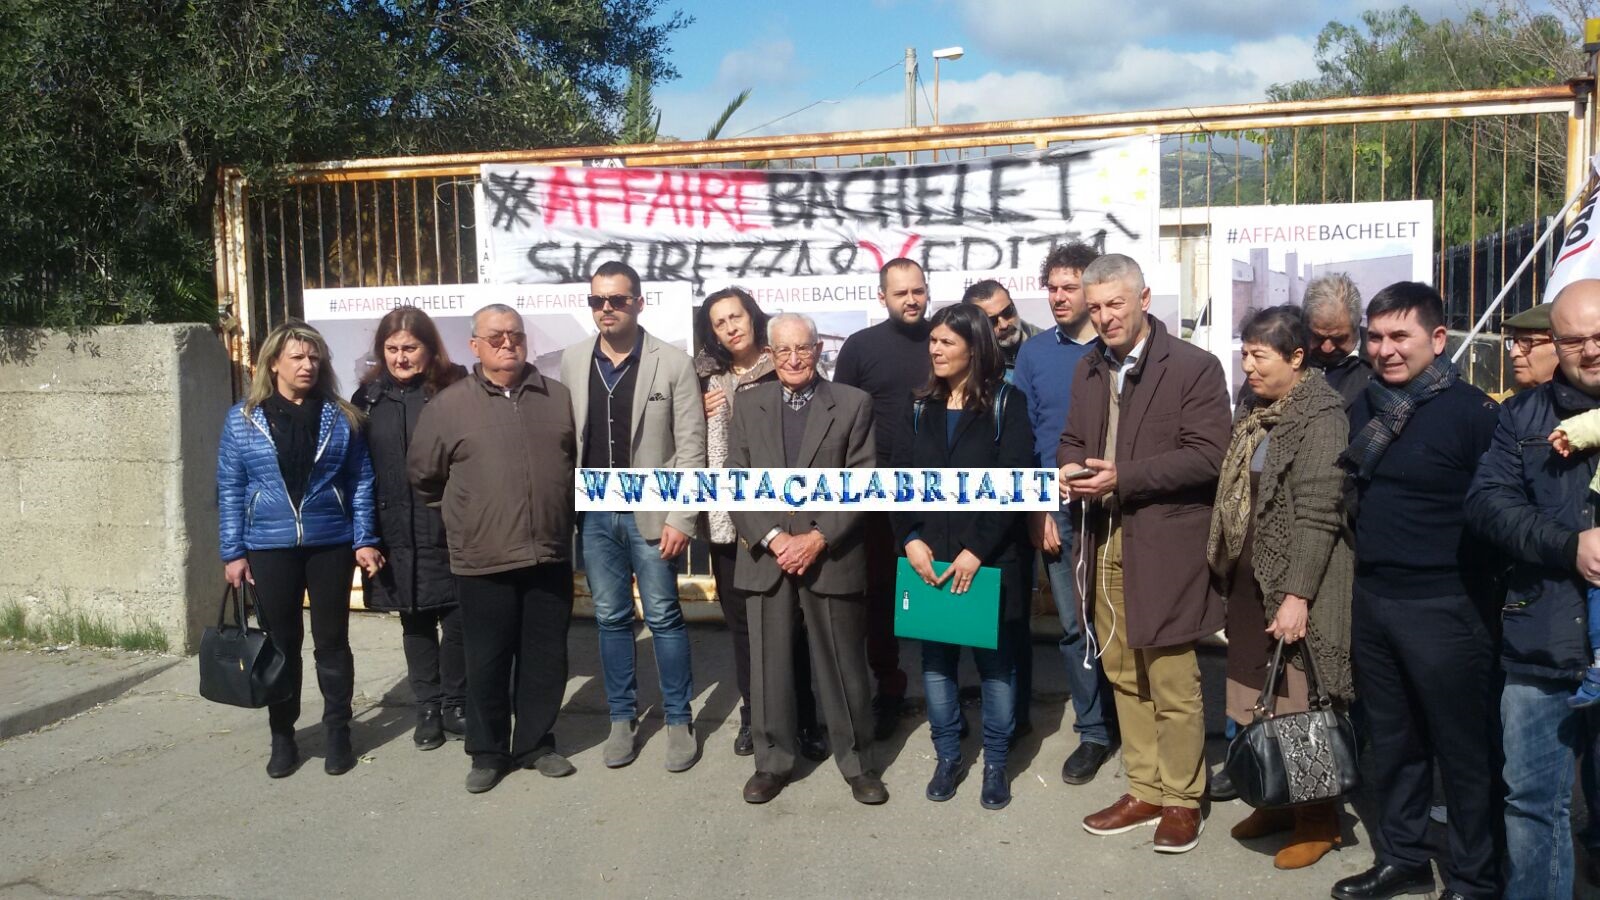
1501, 673, 1600, 900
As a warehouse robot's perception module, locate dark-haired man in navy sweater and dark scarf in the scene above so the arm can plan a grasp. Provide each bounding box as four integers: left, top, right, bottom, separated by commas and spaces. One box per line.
1333, 282, 1499, 898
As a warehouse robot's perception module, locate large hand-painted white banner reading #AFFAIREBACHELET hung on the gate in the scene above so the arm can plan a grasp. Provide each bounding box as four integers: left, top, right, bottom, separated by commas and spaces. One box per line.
477, 138, 1160, 336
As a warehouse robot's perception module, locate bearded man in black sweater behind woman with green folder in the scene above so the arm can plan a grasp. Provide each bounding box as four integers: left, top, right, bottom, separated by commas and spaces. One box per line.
834, 258, 931, 740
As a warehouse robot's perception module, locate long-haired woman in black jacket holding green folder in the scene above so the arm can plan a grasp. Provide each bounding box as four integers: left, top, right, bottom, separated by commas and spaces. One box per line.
890, 304, 1034, 809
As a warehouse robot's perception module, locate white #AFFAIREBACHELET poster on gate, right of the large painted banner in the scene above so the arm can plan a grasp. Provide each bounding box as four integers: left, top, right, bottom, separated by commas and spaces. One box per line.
1195, 200, 1434, 396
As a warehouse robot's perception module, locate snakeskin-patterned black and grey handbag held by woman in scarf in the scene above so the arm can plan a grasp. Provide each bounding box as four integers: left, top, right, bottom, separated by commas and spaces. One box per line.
1222, 637, 1362, 809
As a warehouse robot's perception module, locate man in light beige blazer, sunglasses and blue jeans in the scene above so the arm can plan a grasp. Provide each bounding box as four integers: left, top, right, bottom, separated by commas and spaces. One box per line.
562, 263, 706, 772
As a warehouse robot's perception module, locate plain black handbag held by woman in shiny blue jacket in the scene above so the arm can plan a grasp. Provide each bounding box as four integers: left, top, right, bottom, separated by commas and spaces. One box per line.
200, 583, 294, 709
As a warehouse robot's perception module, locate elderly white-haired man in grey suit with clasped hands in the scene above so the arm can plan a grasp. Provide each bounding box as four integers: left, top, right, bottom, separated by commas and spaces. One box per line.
726, 312, 890, 804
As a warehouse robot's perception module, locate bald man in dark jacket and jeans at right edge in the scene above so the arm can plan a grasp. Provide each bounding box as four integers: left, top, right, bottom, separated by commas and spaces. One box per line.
1467, 280, 1600, 898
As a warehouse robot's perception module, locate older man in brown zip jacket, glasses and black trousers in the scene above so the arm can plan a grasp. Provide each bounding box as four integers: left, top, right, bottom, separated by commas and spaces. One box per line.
406, 304, 578, 794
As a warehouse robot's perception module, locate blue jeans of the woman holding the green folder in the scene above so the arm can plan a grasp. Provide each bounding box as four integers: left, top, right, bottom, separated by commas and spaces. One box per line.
922, 626, 1016, 769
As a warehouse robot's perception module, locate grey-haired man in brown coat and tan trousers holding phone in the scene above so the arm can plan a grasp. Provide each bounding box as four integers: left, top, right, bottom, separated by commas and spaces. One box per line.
1056, 253, 1230, 854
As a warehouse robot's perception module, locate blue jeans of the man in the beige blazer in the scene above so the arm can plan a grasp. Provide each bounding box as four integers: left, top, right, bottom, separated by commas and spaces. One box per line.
578, 512, 694, 725
